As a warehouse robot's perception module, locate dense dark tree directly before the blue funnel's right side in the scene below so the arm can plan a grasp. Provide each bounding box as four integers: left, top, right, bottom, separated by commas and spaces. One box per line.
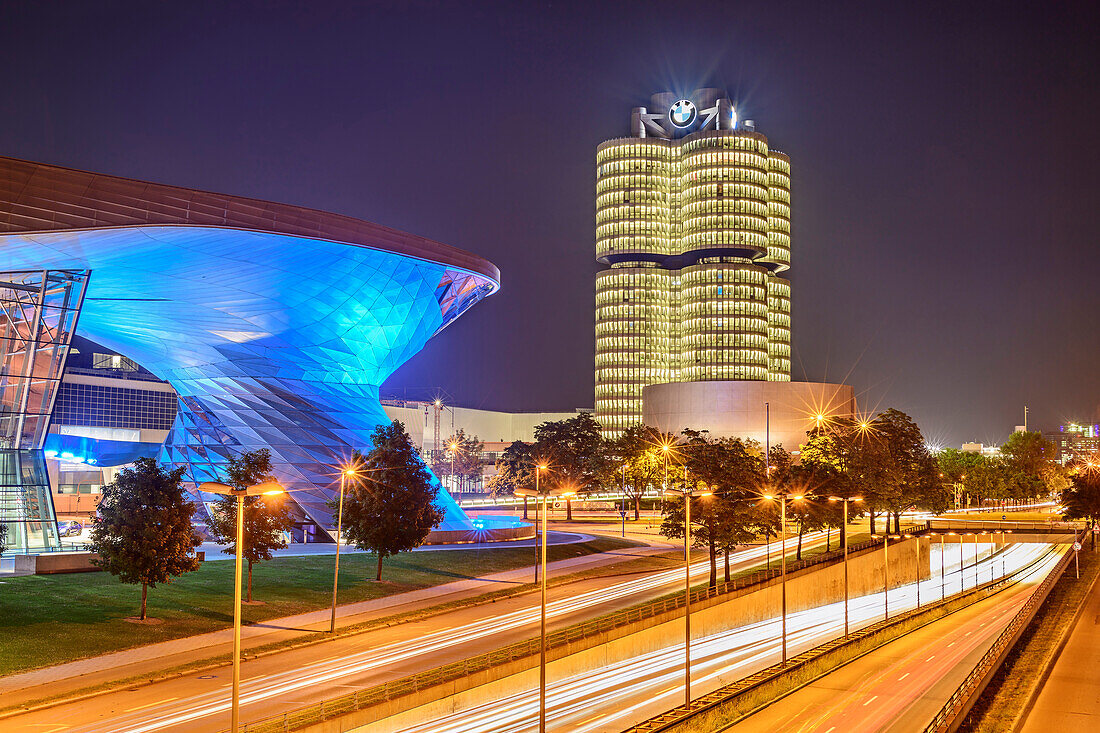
329, 420, 443, 580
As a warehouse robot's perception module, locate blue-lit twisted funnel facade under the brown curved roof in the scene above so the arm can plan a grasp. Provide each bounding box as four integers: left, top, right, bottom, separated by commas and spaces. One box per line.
0, 225, 497, 529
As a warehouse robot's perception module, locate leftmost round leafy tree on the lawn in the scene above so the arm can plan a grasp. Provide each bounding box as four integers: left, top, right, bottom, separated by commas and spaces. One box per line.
89, 458, 202, 621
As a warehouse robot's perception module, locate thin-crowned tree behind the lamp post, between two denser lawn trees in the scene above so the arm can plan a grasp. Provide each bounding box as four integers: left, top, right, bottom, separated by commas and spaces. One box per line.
209, 448, 294, 603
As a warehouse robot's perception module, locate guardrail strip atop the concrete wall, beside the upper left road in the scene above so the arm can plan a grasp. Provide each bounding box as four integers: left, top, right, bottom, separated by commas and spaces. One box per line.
238, 527, 915, 733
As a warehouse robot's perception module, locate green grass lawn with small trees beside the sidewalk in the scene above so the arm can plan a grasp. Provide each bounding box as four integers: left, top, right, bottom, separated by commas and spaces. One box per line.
0, 530, 637, 676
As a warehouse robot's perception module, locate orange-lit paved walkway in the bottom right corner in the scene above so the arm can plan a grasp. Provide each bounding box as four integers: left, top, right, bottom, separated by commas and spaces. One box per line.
1020, 570, 1100, 733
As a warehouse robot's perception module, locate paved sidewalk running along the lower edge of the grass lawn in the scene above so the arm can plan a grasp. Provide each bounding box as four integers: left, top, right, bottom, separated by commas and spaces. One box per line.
0, 539, 667, 707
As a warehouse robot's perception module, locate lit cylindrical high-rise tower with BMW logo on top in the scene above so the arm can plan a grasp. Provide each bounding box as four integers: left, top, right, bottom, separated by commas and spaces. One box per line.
595, 89, 791, 436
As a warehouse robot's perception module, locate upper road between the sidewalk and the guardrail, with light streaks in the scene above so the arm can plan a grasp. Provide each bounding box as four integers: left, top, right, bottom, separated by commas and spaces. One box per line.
0, 535, 824, 733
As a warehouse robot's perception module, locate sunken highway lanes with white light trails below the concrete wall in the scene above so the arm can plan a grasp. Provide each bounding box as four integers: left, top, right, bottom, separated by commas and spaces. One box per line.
387, 545, 1054, 733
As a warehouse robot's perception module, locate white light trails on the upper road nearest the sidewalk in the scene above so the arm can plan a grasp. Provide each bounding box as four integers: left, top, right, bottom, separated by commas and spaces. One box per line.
64, 532, 825, 733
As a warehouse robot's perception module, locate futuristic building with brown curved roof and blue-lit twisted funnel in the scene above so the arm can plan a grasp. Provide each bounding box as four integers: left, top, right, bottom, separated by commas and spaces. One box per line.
0, 157, 521, 551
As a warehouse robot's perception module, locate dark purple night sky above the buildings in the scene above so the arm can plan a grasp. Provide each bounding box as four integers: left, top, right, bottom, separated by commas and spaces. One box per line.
0, 0, 1100, 446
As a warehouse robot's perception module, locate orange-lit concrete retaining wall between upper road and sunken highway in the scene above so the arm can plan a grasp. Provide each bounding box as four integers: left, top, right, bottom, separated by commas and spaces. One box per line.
332, 530, 931, 733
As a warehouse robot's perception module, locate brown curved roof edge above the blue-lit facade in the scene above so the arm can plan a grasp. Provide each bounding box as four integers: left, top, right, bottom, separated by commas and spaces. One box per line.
0, 156, 501, 284
